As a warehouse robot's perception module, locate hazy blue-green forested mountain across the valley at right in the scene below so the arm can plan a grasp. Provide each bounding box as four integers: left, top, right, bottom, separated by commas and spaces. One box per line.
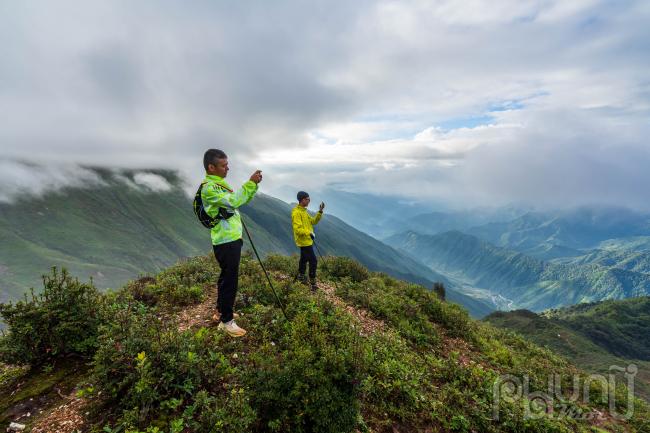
387, 231, 650, 311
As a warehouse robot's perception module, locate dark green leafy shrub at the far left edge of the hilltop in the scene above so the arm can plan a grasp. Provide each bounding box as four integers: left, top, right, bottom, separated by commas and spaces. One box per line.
0, 268, 101, 365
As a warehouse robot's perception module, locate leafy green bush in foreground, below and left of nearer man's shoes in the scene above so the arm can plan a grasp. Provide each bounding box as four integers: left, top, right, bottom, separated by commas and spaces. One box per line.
94, 293, 255, 432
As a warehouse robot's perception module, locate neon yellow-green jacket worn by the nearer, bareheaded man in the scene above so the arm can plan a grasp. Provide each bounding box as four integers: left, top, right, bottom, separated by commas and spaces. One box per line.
201, 174, 257, 245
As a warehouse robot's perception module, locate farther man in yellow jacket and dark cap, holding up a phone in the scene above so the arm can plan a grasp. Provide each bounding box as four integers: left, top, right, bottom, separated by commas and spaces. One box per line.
291, 191, 325, 291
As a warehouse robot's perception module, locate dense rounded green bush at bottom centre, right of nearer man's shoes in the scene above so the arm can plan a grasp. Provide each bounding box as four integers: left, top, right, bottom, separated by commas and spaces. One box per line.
243, 291, 363, 433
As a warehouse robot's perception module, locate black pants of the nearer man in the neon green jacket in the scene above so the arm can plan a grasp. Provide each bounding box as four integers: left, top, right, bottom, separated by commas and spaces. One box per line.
212, 239, 244, 323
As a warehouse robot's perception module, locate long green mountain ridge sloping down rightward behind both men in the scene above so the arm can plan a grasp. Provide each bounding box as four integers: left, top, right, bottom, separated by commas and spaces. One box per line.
0, 169, 492, 317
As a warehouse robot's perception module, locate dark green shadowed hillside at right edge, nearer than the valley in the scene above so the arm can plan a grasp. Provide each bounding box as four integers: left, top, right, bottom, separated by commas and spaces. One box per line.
485, 297, 650, 399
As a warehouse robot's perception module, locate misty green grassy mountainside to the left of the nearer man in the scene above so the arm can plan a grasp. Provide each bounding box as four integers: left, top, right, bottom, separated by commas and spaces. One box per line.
0, 171, 206, 298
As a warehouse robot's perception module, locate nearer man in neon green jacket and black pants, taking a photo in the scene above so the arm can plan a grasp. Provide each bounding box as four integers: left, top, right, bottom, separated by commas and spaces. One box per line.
201, 149, 262, 337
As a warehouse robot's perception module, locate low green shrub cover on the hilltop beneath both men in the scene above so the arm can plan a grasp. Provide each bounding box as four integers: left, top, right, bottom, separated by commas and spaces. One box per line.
1, 256, 648, 432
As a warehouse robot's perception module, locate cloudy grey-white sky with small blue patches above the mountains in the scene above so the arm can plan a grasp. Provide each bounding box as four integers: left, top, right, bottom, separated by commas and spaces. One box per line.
0, 0, 650, 208
